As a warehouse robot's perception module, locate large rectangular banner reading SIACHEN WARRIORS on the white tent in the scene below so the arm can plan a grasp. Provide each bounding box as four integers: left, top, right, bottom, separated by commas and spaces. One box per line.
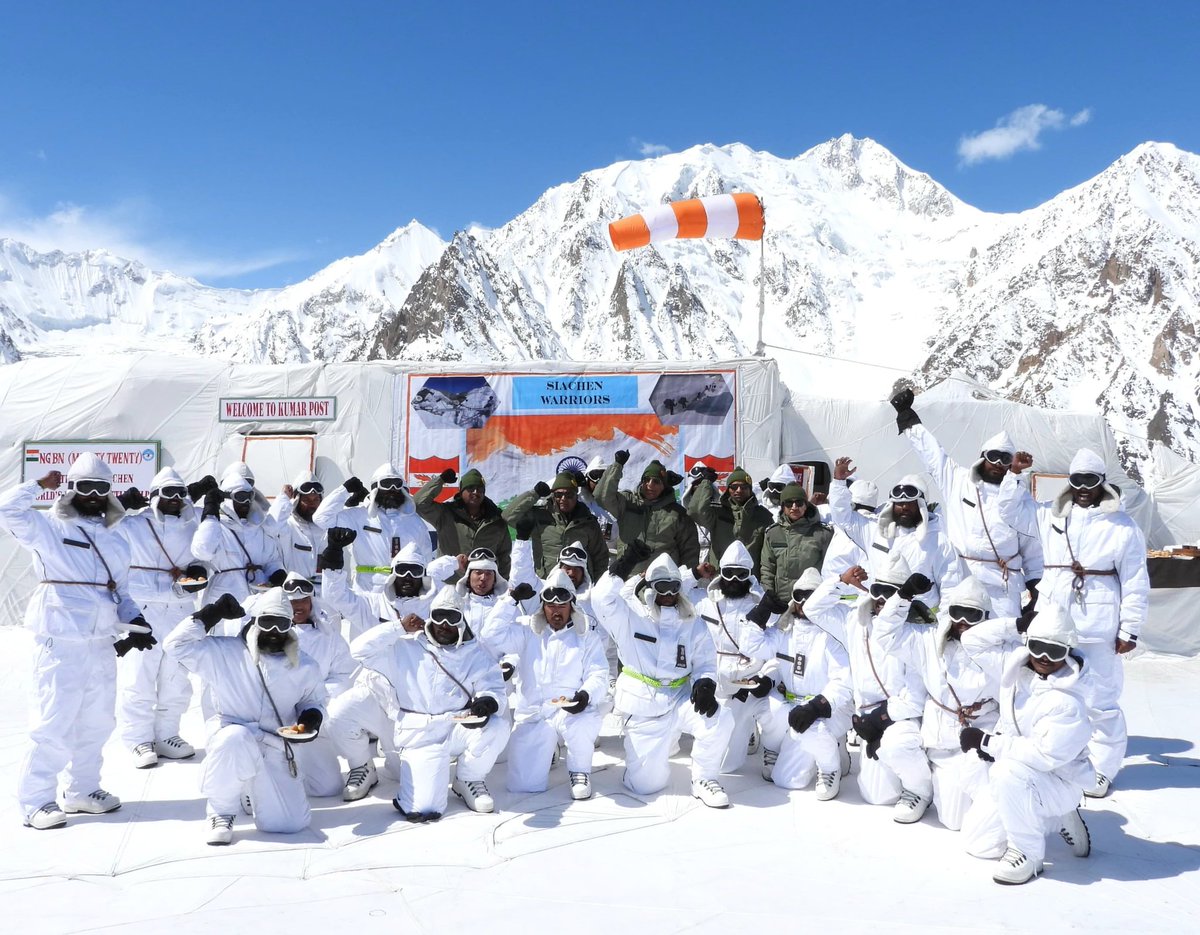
397, 368, 737, 503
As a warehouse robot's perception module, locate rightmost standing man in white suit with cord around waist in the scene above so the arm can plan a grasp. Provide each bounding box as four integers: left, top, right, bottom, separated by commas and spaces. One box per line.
1001, 448, 1150, 798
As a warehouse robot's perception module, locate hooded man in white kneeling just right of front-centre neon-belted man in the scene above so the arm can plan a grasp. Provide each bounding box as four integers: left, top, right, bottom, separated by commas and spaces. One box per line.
696, 540, 775, 773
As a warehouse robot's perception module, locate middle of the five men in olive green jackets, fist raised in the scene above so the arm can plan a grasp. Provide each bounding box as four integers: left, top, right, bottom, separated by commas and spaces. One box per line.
595, 451, 700, 575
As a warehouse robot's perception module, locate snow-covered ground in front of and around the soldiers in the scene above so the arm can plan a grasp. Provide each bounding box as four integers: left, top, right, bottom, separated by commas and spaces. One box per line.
0, 627, 1200, 935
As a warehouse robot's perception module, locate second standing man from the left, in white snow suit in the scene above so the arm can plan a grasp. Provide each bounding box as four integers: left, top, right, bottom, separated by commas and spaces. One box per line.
114, 467, 209, 769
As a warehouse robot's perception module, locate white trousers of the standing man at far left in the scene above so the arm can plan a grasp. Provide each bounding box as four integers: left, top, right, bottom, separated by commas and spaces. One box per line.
17, 636, 117, 817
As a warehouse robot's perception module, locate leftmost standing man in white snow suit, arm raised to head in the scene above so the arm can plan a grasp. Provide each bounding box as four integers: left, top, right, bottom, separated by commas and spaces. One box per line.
0, 451, 155, 829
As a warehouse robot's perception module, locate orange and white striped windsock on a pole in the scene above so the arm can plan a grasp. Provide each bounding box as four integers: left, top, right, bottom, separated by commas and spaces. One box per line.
608, 192, 763, 251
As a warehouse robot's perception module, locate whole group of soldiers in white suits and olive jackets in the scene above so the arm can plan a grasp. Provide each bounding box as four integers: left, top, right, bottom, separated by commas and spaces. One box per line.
0, 392, 1148, 883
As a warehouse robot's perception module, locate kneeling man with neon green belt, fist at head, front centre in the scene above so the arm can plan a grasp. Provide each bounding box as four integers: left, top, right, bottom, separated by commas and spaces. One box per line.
592, 552, 733, 808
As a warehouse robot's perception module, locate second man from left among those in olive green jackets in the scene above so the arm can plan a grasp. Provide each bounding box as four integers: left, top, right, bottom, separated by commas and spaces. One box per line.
503, 471, 608, 581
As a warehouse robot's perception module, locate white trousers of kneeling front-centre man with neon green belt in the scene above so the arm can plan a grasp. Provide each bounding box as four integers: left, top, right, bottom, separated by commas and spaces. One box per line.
624, 696, 733, 796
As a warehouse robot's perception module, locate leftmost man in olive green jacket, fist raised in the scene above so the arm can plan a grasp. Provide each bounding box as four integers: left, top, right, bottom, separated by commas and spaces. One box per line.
413, 468, 512, 579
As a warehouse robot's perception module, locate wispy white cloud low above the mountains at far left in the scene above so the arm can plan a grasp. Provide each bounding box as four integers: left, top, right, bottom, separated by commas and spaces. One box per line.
0, 194, 302, 282
